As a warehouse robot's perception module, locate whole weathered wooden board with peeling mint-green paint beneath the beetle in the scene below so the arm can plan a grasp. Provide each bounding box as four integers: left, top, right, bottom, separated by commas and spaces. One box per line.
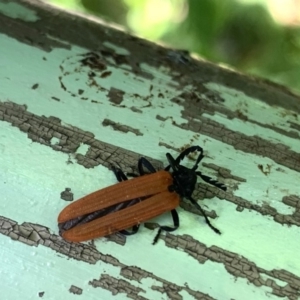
0, 1, 300, 300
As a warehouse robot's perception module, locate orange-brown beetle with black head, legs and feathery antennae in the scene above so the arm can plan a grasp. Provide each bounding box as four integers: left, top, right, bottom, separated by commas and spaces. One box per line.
58, 146, 226, 244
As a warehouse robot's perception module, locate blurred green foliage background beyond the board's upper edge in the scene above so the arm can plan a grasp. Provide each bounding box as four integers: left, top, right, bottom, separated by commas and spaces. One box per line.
48, 0, 300, 94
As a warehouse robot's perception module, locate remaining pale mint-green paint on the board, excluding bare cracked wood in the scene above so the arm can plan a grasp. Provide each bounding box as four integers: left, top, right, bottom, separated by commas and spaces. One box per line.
0, 2, 300, 300
